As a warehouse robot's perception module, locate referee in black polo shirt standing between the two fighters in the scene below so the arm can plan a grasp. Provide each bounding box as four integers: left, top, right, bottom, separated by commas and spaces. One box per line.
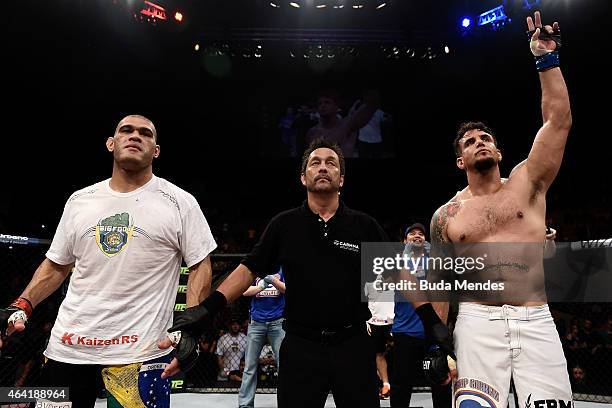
168, 139, 450, 408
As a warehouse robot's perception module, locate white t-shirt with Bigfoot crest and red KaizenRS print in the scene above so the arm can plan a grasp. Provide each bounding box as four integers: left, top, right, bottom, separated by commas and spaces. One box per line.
44, 176, 217, 365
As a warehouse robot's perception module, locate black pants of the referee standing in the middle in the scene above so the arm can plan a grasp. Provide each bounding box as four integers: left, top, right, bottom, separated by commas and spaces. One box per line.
277, 330, 380, 408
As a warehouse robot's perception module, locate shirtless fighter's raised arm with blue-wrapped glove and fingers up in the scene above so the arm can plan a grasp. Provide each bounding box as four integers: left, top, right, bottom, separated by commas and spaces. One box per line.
526, 11, 572, 192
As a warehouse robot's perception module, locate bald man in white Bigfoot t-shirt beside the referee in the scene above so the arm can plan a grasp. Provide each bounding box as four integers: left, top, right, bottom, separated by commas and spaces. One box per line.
0, 115, 216, 407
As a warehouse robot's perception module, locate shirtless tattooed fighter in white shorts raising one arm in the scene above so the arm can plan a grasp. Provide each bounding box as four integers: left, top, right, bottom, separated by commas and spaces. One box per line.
431, 12, 572, 408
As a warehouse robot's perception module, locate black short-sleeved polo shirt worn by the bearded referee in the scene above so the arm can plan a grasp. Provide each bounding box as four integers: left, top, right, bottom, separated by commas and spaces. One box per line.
242, 201, 387, 329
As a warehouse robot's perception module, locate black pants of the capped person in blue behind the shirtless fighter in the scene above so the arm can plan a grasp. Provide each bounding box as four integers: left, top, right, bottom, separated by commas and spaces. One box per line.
391, 333, 452, 408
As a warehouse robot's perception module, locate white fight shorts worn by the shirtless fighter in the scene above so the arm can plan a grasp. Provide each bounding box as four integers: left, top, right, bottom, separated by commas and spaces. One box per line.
453, 302, 573, 408
